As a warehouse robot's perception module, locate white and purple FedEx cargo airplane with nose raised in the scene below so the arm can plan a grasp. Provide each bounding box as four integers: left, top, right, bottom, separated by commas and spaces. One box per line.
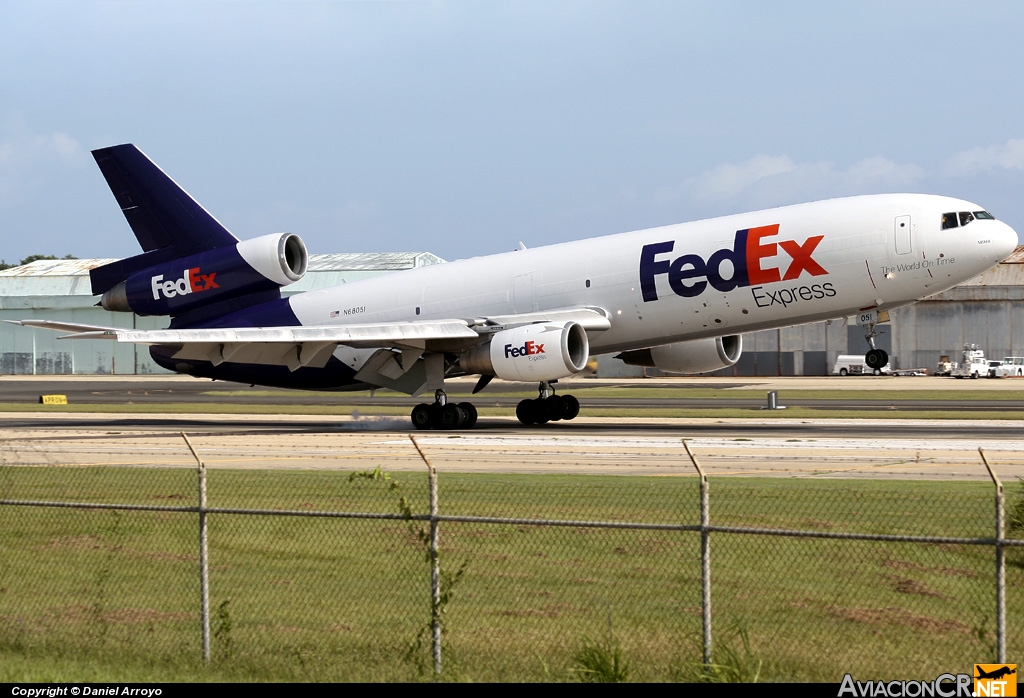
6, 144, 1018, 429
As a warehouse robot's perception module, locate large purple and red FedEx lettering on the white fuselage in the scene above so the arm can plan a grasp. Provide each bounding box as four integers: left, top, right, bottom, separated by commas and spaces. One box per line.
640, 223, 828, 303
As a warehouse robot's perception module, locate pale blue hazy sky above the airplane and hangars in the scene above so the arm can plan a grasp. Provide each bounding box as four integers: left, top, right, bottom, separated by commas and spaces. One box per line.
0, 0, 1024, 262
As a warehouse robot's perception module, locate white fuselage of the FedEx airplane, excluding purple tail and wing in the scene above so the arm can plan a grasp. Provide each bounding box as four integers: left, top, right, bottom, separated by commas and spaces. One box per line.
290, 194, 1017, 359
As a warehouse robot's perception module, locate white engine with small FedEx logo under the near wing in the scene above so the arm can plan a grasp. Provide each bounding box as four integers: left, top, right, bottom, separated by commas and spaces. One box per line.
459, 322, 590, 382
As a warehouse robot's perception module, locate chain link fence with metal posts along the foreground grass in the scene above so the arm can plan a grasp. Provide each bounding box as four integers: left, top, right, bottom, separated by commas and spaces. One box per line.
0, 429, 1024, 682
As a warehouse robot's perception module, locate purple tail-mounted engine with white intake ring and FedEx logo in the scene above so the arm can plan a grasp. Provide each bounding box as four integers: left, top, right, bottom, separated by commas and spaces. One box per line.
100, 232, 309, 315
